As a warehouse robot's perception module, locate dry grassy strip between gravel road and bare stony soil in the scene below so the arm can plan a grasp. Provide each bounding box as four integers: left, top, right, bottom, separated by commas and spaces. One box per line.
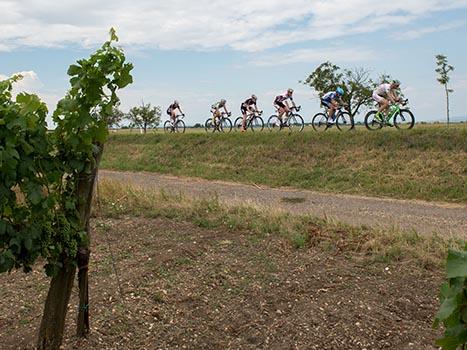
95, 182, 463, 268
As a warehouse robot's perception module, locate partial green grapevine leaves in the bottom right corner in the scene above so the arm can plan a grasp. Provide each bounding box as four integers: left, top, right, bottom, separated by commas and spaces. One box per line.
434, 247, 467, 350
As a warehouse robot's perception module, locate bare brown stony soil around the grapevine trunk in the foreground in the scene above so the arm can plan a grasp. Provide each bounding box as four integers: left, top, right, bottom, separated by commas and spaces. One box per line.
0, 217, 442, 350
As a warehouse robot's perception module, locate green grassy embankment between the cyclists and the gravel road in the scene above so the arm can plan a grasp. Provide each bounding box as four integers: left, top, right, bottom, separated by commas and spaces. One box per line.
102, 125, 467, 203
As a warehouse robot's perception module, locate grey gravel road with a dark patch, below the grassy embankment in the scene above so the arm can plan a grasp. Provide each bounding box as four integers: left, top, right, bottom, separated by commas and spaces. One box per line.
99, 170, 467, 238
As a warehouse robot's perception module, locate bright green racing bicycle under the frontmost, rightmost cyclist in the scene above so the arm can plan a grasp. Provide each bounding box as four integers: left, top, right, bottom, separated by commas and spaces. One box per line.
365, 100, 415, 131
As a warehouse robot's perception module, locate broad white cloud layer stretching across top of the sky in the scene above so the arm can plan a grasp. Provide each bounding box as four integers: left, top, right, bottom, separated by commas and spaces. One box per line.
0, 0, 467, 51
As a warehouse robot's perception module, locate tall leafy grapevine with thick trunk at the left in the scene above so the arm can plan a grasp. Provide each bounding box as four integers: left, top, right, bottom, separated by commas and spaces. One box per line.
0, 29, 133, 349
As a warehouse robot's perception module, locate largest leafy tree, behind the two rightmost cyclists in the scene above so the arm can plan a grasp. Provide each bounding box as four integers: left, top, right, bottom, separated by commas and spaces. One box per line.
303, 61, 373, 117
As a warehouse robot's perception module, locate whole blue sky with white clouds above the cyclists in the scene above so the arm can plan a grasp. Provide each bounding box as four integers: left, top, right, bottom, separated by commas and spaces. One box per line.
0, 0, 467, 124
